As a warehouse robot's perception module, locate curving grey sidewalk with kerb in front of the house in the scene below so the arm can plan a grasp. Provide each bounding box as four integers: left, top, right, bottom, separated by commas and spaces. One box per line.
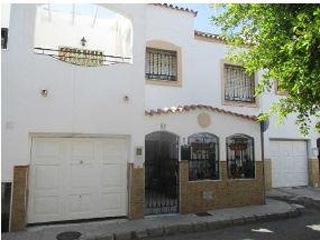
1, 199, 300, 240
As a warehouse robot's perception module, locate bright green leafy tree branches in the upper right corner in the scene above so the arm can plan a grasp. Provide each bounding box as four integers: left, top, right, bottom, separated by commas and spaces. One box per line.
212, 4, 320, 134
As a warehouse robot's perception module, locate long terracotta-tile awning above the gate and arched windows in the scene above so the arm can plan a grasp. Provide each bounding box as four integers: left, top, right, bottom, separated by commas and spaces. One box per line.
145, 104, 257, 121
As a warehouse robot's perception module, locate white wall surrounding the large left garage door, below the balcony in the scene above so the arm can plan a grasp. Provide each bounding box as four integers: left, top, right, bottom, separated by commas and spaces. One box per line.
1, 4, 145, 181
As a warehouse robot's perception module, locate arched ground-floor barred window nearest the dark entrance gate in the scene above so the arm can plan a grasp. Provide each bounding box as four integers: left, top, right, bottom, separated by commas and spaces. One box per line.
188, 133, 219, 181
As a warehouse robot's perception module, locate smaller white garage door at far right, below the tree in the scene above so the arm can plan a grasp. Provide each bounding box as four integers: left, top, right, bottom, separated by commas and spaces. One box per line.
270, 141, 308, 187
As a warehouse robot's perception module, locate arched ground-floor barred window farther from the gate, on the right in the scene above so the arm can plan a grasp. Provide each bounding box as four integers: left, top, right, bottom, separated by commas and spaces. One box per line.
227, 134, 255, 179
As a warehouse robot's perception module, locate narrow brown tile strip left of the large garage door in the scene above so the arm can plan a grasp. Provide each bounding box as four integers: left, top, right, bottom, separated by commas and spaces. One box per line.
10, 166, 29, 231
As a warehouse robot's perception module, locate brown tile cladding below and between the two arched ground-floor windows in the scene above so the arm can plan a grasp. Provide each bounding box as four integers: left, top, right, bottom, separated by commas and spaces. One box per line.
180, 161, 264, 213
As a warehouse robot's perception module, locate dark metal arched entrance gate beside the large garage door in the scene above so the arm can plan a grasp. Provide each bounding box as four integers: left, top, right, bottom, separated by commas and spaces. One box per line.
145, 132, 179, 215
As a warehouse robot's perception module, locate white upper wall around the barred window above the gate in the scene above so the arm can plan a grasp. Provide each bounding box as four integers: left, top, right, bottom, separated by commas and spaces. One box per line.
145, 5, 194, 109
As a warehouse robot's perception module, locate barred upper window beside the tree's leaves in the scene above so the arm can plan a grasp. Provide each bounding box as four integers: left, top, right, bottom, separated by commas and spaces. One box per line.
224, 64, 255, 103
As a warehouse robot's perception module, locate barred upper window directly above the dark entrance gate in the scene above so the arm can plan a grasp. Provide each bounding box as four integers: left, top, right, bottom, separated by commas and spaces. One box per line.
145, 48, 177, 81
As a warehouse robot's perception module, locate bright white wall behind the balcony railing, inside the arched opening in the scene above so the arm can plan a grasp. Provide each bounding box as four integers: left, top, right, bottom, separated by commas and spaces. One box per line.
34, 6, 132, 57
